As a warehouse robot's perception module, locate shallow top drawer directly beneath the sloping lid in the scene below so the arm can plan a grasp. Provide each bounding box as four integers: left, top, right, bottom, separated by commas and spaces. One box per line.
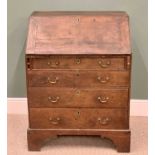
29, 56, 126, 70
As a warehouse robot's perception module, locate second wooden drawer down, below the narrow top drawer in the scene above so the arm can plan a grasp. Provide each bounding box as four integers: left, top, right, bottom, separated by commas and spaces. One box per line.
28, 70, 129, 88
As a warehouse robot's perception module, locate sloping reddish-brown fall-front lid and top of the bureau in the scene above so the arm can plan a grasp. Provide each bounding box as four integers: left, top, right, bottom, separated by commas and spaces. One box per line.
26, 12, 131, 55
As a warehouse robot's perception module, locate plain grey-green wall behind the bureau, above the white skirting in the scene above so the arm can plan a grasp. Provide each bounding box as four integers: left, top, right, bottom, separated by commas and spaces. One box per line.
7, 0, 148, 99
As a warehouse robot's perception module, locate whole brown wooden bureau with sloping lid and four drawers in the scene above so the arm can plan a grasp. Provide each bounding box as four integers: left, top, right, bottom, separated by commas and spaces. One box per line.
26, 12, 131, 152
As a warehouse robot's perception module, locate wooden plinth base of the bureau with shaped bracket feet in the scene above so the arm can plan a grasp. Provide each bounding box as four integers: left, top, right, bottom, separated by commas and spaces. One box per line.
27, 129, 130, 152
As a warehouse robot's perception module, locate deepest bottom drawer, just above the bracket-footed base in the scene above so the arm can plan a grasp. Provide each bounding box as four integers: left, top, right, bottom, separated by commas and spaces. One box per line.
29, 108, 129, 129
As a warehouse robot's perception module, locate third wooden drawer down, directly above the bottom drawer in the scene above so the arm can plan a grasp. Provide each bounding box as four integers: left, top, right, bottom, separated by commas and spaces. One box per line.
28, 87, 128, 108
